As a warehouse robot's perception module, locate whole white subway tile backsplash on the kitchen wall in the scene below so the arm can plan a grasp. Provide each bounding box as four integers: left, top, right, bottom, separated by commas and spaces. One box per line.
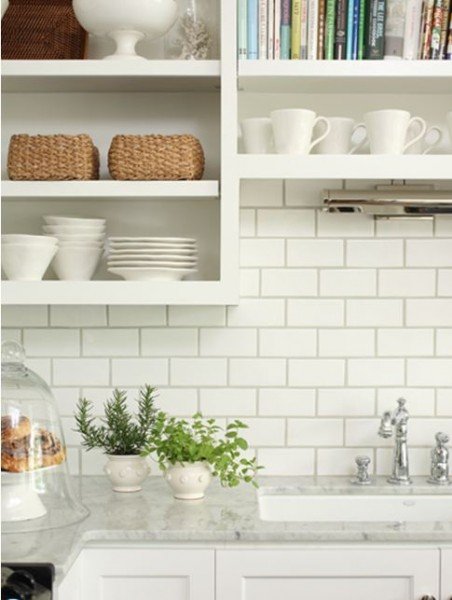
3, 181, 452, 475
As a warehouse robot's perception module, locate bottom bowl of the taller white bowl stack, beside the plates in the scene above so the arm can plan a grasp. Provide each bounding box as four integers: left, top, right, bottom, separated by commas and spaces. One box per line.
52, 247, 102, 281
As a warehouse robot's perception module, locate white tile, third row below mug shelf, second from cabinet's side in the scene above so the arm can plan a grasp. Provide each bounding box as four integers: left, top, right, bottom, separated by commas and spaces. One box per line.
287, 239, 344, 267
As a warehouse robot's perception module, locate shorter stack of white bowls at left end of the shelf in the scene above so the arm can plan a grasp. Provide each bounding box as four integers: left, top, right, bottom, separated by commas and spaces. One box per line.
2, 234, 58, 281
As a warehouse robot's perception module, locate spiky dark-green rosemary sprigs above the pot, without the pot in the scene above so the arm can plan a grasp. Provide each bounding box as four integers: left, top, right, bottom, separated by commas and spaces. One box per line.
75, 385, 157, 456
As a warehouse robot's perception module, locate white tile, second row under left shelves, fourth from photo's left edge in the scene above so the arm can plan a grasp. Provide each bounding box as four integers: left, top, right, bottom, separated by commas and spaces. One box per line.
141, 327, 198, 356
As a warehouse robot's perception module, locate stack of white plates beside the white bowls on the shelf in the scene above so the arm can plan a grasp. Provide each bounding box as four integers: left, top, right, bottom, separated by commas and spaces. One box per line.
108, 237, 198, 281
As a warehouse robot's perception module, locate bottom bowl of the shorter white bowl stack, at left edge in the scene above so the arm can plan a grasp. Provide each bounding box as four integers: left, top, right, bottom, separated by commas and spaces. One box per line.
2, 244, 58, 281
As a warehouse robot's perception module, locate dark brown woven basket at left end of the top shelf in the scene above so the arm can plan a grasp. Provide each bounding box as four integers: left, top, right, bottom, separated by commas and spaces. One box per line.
2, 0, 87, 60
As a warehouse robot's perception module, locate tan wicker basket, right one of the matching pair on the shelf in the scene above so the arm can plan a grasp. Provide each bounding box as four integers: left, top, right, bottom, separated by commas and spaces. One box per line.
108, 135, 204, 181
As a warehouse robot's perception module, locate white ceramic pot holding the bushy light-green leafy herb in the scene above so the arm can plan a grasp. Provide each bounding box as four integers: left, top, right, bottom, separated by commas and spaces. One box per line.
164, 462, 212, 500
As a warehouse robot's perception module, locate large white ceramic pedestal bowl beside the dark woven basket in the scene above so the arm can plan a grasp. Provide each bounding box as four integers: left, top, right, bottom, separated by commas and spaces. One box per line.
72, 0, 177, 60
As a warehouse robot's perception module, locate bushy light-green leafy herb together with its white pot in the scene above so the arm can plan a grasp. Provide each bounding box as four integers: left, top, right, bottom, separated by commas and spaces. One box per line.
143, 412, 261, 500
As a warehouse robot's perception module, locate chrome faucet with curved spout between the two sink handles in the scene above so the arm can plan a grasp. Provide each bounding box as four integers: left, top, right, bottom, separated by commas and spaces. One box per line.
378, 398, 412, 485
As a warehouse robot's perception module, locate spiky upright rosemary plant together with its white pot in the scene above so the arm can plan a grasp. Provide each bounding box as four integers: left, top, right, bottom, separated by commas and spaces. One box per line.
75, 385, 157, 492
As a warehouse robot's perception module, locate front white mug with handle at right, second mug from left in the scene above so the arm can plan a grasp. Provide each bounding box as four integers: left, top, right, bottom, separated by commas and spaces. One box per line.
270, 108, 331, 154
